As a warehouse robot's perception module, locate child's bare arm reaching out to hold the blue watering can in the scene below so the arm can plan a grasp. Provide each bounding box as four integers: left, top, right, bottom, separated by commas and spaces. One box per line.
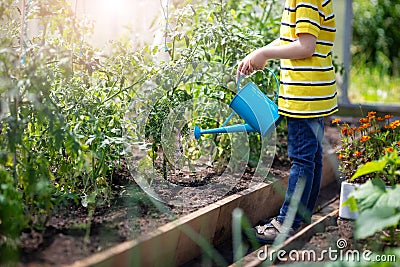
237, 33, 317, 77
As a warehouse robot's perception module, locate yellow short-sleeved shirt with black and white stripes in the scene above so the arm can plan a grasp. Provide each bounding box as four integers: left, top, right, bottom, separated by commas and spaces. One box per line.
278, 0, 338, 118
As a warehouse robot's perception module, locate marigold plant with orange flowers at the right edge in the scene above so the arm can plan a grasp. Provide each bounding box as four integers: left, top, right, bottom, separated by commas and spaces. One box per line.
332, 111, 400, 183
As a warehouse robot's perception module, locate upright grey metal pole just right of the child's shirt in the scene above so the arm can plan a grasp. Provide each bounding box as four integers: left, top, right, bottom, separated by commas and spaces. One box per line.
341, 0, 353, 104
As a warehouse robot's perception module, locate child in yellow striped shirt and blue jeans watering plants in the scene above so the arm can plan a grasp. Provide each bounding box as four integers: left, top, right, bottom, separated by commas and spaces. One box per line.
237, 0, 337, 243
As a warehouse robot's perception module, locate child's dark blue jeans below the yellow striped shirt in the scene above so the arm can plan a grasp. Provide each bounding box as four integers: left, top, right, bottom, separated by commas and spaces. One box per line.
277, 117, 324, 230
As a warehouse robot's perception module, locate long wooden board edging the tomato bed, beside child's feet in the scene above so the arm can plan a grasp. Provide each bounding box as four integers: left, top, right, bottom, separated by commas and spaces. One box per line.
72, 153, 336, 267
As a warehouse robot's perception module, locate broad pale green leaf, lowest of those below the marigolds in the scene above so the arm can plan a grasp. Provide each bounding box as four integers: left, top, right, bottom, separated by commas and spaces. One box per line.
355, 206, 400, 239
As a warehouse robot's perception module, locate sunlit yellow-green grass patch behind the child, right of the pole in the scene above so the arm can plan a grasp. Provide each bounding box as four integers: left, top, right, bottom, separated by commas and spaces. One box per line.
349, 65, 400, 104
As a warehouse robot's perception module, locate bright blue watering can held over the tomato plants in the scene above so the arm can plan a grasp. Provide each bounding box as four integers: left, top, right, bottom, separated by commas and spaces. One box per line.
194, 68, 282, 139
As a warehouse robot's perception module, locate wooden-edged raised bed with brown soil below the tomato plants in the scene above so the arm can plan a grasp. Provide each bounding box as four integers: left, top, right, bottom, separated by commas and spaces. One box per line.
16, 120, 336, 266
